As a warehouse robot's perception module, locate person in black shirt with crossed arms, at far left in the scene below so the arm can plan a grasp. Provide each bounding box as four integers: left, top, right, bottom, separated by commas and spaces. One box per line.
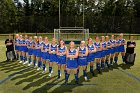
5, 35, 15, 61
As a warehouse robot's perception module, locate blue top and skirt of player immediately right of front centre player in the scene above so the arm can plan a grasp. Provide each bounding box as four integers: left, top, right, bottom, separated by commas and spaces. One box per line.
78, 47, 88, 66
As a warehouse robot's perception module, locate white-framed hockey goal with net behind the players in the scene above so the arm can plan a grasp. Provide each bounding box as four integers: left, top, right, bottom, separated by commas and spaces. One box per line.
54, 28, 89, 44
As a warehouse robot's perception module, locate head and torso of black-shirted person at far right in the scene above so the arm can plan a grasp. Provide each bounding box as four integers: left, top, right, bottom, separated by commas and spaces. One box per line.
126, 36, 136, 54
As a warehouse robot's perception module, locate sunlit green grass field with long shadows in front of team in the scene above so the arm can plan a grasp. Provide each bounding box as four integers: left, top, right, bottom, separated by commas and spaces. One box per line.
0, 40, 140, 93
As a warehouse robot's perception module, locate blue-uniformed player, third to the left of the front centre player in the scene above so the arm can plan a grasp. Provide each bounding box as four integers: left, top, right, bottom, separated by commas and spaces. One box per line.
41, 37, 50, 73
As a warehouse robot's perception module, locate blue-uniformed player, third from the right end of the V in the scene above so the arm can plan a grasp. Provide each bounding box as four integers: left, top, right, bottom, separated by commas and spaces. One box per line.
110, 35, 116, 65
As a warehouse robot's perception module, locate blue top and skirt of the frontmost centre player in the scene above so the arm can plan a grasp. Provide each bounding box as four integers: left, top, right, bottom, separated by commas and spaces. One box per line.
66, 49, 78, 69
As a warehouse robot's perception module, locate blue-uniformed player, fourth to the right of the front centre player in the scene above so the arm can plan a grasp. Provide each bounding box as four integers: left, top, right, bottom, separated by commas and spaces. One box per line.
101, 36, 107, 69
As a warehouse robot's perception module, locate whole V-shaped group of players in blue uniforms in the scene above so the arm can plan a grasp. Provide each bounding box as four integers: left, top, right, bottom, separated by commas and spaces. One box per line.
15, 34, 125, 84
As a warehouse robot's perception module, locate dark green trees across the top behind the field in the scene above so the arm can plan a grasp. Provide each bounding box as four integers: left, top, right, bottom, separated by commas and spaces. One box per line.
0, 0, 140, 33
